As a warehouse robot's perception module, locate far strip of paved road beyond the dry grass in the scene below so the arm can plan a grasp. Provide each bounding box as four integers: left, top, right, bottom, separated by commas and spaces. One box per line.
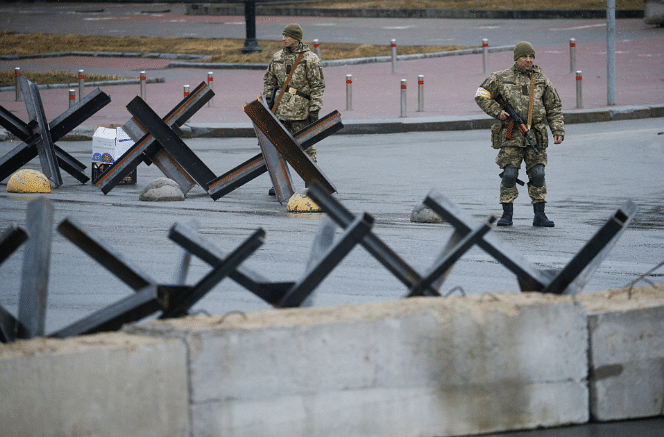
0, 3, 664, 47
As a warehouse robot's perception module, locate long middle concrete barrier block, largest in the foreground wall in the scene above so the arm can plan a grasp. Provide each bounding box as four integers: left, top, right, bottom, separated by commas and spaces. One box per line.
132, 293, 588, 437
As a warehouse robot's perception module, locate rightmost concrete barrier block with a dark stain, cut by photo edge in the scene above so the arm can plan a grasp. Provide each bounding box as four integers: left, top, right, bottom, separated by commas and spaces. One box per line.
579, 284, 664, 421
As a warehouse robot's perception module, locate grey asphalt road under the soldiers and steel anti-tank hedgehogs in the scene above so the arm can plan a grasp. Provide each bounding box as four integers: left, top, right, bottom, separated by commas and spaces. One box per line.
0, 119, 664, 331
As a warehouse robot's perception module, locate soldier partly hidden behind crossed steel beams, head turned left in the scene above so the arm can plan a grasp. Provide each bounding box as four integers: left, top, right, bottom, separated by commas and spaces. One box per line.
263, 24, 325, 195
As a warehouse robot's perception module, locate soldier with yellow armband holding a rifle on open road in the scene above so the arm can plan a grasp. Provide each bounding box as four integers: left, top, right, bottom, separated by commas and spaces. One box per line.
475, 41, 565, 227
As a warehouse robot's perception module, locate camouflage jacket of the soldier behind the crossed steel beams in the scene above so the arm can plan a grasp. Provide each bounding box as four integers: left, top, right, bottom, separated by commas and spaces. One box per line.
263, 43, 325, 120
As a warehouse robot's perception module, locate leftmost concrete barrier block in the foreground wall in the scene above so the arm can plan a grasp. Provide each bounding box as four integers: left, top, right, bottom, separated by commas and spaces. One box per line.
0, 333, 189, 437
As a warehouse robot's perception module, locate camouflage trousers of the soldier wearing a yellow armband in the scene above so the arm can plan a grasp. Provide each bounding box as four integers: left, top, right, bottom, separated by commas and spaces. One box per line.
496, 147, 547, 204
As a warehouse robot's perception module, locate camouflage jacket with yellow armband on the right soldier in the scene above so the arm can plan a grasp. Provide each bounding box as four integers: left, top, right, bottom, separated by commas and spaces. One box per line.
475, 64, 565, 143
